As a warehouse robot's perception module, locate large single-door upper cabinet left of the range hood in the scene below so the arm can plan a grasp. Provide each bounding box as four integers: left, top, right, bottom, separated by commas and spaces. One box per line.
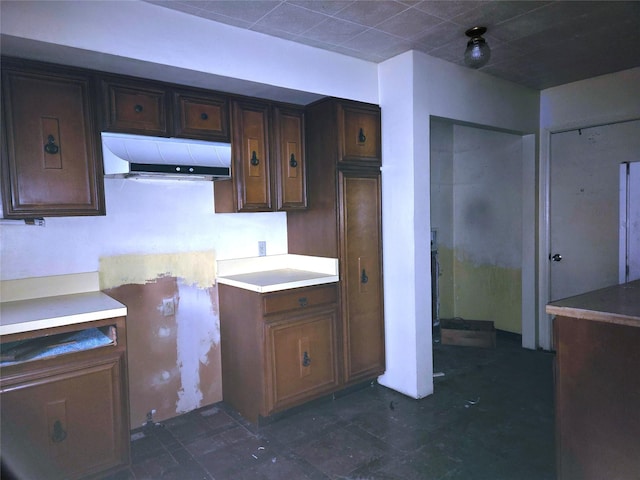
2, 59, 105, 218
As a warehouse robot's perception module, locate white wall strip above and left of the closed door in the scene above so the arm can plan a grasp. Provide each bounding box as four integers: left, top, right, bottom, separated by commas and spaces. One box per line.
538, 67, 640, 349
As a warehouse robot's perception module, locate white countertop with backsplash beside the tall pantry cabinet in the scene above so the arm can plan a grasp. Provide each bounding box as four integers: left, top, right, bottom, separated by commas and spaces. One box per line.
217, 254, 340, 293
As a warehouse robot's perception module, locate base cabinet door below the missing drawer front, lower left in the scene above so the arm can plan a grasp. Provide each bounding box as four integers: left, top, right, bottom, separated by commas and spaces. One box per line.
0, 359, 129, 479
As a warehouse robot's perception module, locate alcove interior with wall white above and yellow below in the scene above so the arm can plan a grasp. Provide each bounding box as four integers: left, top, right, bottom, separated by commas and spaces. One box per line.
430, 118, 533, 334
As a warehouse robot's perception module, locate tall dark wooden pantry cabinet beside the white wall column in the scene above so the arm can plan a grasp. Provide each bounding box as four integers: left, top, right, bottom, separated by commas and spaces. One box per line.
287, 99, 385, 385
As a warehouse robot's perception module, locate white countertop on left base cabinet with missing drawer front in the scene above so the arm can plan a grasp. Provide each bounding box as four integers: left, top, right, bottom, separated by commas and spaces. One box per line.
0, 292, 127, 335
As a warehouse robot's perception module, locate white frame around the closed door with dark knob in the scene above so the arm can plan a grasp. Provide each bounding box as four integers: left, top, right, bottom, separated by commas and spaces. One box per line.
537, 115, 640, 350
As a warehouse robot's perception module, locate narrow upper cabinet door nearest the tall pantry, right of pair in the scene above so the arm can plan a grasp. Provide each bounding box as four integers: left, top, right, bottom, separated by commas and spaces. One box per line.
274, 107, 307, 211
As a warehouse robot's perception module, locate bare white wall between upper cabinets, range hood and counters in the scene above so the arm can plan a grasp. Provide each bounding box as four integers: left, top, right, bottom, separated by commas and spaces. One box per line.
0, 179, 287, 280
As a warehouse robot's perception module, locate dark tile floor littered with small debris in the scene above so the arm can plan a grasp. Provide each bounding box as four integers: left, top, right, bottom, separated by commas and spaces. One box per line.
105, 334, 555, 480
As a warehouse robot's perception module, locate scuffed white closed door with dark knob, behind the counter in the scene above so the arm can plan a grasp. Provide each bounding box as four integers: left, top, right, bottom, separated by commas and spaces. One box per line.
549, 121, 640, 301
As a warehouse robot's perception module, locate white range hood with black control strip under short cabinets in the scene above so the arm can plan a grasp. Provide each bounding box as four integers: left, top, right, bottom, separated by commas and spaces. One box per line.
102, 132, 231, 180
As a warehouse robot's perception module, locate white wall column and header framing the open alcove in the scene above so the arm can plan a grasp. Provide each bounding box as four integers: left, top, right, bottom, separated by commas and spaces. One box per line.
379, 52, 539, 398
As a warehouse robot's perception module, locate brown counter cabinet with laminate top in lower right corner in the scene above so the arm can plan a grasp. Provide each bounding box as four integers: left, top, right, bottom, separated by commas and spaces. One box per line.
546, 280, 640, 480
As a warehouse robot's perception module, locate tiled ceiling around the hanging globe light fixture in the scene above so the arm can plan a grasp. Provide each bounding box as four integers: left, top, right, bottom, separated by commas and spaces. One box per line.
147, 0, 640, 90
